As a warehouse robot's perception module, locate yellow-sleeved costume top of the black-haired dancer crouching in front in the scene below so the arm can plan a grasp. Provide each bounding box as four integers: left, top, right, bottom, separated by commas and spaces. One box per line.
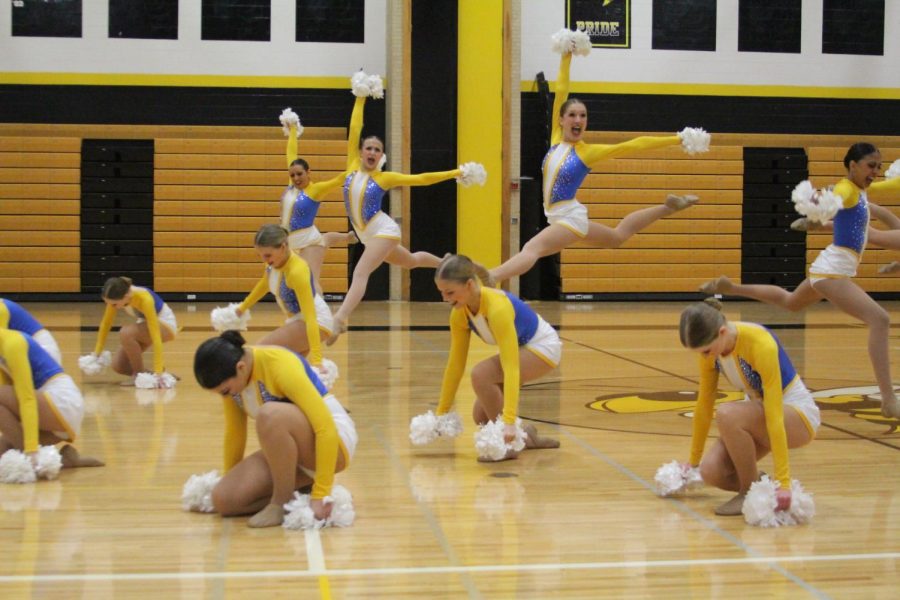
222, 346, 350, 500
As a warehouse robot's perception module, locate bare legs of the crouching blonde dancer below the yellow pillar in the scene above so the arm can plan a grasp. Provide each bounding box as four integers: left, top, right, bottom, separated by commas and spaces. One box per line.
472, 348, 559, 462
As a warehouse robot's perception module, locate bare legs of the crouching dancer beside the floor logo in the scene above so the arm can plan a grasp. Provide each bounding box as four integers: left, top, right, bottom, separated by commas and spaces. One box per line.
700, 402, 812, 516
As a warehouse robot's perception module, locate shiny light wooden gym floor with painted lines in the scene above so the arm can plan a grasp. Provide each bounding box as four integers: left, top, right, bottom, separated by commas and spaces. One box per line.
0, 300, 900, 599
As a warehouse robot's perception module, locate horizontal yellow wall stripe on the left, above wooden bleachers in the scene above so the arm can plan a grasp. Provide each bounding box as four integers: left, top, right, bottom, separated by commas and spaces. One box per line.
0, 73, 370, 89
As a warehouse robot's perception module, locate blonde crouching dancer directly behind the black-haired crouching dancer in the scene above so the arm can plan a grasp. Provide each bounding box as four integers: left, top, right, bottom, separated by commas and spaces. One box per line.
230, 225, 332, 368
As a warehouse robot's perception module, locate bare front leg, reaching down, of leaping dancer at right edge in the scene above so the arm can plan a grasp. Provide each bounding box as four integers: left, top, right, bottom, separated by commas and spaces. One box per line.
816, 279, 900, 418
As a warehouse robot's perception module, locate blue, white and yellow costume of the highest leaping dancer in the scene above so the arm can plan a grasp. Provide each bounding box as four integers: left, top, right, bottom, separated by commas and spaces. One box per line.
541, 53, 681, 237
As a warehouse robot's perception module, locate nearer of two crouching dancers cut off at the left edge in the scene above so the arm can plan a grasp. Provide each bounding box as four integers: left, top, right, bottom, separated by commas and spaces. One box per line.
0, 329, 103, 468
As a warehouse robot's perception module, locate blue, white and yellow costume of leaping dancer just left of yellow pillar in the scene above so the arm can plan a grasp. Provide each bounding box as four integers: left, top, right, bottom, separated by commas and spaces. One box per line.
344, 97, 460, 242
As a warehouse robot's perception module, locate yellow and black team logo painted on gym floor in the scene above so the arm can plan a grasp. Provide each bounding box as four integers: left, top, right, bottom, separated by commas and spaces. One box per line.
587, 386, 900, 433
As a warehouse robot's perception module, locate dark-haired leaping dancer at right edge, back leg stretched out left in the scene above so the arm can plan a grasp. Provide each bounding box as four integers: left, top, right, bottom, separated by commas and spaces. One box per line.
700, 142, 900, 418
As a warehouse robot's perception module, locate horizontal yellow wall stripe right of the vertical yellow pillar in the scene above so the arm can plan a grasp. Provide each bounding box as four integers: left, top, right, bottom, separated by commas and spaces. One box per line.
522, 81, 900, 100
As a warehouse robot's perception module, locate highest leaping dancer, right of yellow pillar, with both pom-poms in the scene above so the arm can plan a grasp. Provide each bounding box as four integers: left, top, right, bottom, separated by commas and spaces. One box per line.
490, 29, 709, 282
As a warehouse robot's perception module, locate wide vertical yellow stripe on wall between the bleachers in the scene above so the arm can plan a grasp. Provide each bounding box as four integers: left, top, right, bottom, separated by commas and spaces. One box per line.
456, 0, 503, 268
